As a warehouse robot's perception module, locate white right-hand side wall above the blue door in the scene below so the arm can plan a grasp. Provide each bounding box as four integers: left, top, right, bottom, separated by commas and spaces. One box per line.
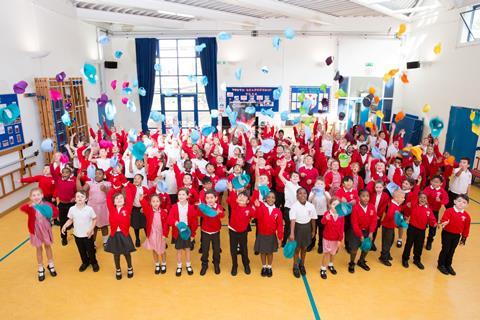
402, 10, 480, 146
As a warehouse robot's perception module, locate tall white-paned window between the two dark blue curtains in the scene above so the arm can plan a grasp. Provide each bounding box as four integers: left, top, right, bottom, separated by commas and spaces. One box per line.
149, 39, 210, 128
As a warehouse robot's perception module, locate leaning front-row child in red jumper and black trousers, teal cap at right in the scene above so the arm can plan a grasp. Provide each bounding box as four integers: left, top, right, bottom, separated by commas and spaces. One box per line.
379, 190, 405, 267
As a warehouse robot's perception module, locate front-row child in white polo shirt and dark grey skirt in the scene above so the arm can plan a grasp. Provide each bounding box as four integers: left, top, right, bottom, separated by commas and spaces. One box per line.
289, 188, 317, 278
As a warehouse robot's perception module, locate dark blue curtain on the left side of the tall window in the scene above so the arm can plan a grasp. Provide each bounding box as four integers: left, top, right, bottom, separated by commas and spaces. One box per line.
135, 38, 158, 132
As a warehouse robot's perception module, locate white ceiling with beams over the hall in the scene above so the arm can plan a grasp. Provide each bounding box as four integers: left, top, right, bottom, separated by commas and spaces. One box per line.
71, 0, 480, 31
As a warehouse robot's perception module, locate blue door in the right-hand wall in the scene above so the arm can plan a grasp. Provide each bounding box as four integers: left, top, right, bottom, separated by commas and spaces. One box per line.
445, 107, 478, 166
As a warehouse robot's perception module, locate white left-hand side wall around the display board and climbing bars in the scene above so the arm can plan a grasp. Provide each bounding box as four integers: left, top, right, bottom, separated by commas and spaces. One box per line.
0, 0, 98, 212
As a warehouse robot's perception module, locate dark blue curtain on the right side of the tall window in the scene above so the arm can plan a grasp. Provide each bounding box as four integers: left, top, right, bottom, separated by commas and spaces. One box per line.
197, 38, 218, 127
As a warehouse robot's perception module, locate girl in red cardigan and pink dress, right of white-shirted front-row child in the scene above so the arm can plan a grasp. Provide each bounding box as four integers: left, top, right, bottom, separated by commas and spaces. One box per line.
320, 197, 344, 279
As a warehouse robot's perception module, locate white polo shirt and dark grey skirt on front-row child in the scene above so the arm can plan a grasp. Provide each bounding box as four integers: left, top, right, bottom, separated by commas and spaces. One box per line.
289, 201, 317, 248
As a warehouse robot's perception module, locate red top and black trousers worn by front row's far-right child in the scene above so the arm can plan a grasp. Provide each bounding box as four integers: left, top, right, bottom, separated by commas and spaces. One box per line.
438, 207, 471, 268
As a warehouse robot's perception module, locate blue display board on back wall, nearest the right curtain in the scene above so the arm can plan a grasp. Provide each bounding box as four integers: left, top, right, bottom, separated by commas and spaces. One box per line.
226, 87, 278, 111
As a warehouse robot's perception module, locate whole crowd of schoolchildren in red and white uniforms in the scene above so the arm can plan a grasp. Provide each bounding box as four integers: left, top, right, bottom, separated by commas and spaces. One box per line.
21, 120, 471, 281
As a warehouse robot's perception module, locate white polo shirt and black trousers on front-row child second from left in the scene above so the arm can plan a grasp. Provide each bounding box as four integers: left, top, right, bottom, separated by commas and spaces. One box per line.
68, 205, 98, 265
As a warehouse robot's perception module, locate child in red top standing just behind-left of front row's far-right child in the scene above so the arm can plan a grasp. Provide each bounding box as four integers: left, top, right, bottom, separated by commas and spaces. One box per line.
423, 175, 448, 250
